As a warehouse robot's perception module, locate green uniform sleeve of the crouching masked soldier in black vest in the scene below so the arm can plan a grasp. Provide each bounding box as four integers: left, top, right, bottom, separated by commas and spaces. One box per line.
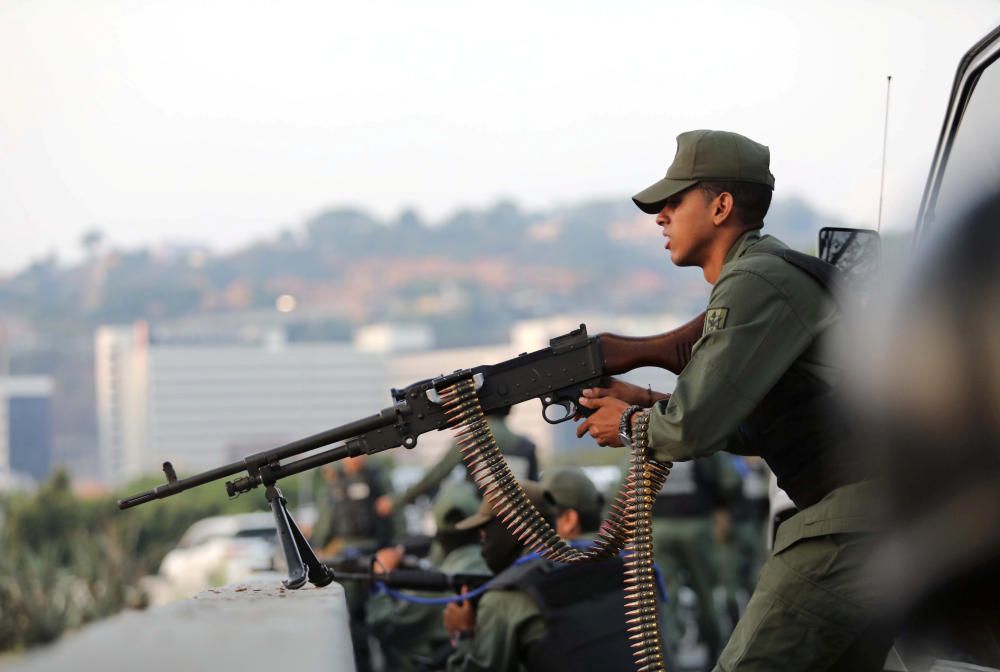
447, 590, 545, 672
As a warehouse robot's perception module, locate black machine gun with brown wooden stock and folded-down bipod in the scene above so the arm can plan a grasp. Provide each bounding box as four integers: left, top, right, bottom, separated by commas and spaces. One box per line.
118, 314, 704, 589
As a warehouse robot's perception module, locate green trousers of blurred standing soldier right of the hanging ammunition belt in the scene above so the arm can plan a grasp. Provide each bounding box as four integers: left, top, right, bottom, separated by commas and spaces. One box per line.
653, 516, 722, 662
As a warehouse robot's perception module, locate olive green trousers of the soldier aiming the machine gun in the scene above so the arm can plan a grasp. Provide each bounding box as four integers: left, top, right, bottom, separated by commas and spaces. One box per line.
715, 534, 892, 672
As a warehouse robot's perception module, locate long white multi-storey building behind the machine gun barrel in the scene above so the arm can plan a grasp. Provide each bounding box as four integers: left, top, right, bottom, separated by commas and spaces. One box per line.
95, 323, 392, 484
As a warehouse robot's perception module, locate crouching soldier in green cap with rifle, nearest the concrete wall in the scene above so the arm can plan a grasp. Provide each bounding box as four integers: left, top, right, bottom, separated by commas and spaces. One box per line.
367, 481, 488, 672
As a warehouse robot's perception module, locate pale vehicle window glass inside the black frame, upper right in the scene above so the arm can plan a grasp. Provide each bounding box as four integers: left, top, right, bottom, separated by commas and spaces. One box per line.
933, 54, 1000, 223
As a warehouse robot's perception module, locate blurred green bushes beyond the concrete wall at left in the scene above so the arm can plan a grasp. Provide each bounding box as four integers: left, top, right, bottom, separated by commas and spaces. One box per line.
0, 472, 309, 651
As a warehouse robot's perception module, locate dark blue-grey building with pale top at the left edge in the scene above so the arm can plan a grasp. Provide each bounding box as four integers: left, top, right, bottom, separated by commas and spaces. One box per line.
0, 376, 52, 482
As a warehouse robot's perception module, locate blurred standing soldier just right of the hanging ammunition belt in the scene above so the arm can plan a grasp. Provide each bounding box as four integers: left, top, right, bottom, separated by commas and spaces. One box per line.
653, 453, 741, 669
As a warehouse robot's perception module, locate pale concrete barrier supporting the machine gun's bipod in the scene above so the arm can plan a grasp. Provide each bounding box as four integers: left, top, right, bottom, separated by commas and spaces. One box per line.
0, 576, 354, 672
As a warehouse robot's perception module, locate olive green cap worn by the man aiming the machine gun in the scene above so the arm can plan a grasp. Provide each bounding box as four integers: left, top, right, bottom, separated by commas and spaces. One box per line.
632, 130, 774, 215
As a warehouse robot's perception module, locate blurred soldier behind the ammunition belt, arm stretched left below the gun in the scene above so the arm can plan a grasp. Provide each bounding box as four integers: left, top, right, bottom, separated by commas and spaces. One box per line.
376, 408, 538, 516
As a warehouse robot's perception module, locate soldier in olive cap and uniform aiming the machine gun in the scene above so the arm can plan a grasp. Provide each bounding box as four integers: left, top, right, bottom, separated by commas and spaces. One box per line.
578, 131, 889, 672
